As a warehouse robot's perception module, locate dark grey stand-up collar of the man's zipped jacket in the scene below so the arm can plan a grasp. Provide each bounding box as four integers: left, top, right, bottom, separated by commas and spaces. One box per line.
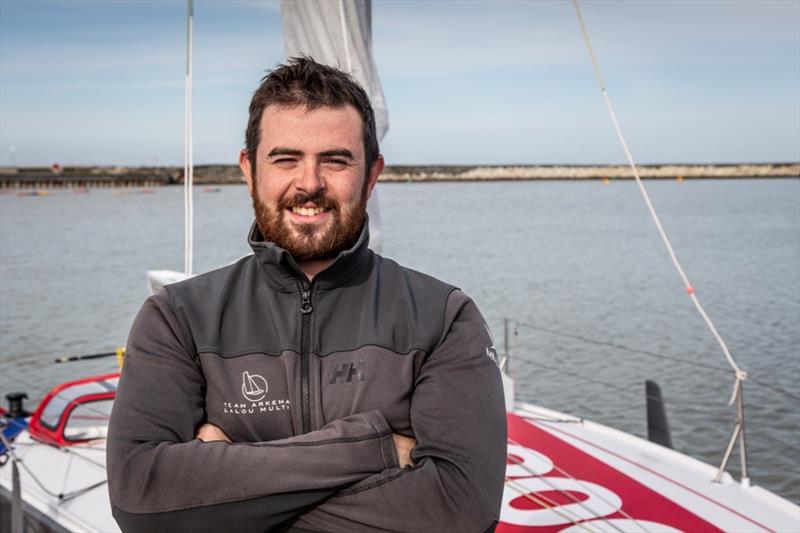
247, 218, 371, 292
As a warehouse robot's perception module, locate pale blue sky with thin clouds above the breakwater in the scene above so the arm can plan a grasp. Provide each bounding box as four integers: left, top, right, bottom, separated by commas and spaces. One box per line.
0, 0, 800, 165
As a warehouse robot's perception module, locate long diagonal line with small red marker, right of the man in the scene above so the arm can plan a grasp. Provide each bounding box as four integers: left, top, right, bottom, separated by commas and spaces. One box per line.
572, 0, 747, 405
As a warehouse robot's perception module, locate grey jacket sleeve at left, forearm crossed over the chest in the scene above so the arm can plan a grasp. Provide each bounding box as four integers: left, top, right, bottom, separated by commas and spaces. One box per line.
107, 291, 397, 532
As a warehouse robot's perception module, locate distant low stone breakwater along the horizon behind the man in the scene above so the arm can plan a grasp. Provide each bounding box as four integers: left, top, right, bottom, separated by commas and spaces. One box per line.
0, 163, 800, 190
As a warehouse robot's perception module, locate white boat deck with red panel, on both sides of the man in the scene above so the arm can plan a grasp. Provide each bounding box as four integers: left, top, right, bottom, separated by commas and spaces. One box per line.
0, 396, 800, 533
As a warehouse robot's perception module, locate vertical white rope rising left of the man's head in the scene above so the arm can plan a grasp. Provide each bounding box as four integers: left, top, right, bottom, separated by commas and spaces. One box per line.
183, 0, 194, 277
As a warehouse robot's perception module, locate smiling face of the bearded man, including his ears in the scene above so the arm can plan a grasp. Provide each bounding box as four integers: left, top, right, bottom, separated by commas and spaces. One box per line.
239, 105, 383, 261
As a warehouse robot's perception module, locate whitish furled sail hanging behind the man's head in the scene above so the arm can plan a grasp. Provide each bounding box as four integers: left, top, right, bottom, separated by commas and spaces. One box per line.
282, 0, 389, 251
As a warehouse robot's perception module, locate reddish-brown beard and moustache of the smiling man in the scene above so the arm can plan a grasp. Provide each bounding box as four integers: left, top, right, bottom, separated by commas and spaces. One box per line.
253, 187, 367, 261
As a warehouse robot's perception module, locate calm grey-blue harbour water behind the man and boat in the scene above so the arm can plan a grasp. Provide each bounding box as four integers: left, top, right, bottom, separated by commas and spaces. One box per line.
0, 180, 800, 503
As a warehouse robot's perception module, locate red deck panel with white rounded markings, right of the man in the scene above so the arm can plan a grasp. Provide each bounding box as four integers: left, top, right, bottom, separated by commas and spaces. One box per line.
497, 414, 721, 533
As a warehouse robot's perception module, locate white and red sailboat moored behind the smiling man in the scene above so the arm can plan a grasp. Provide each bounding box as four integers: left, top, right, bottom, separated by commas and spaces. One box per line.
0, 0, 800, 532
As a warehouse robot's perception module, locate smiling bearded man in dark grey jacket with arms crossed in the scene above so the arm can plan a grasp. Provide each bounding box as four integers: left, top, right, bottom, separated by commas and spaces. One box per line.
108, 58, 506, 532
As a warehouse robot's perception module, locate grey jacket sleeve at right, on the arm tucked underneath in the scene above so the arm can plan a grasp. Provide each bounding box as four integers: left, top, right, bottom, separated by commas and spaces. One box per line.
295, 291, 506, 532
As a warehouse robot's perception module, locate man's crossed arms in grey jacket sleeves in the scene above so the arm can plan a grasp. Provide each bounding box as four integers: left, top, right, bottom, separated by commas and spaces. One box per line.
108, 291, 506, 533
